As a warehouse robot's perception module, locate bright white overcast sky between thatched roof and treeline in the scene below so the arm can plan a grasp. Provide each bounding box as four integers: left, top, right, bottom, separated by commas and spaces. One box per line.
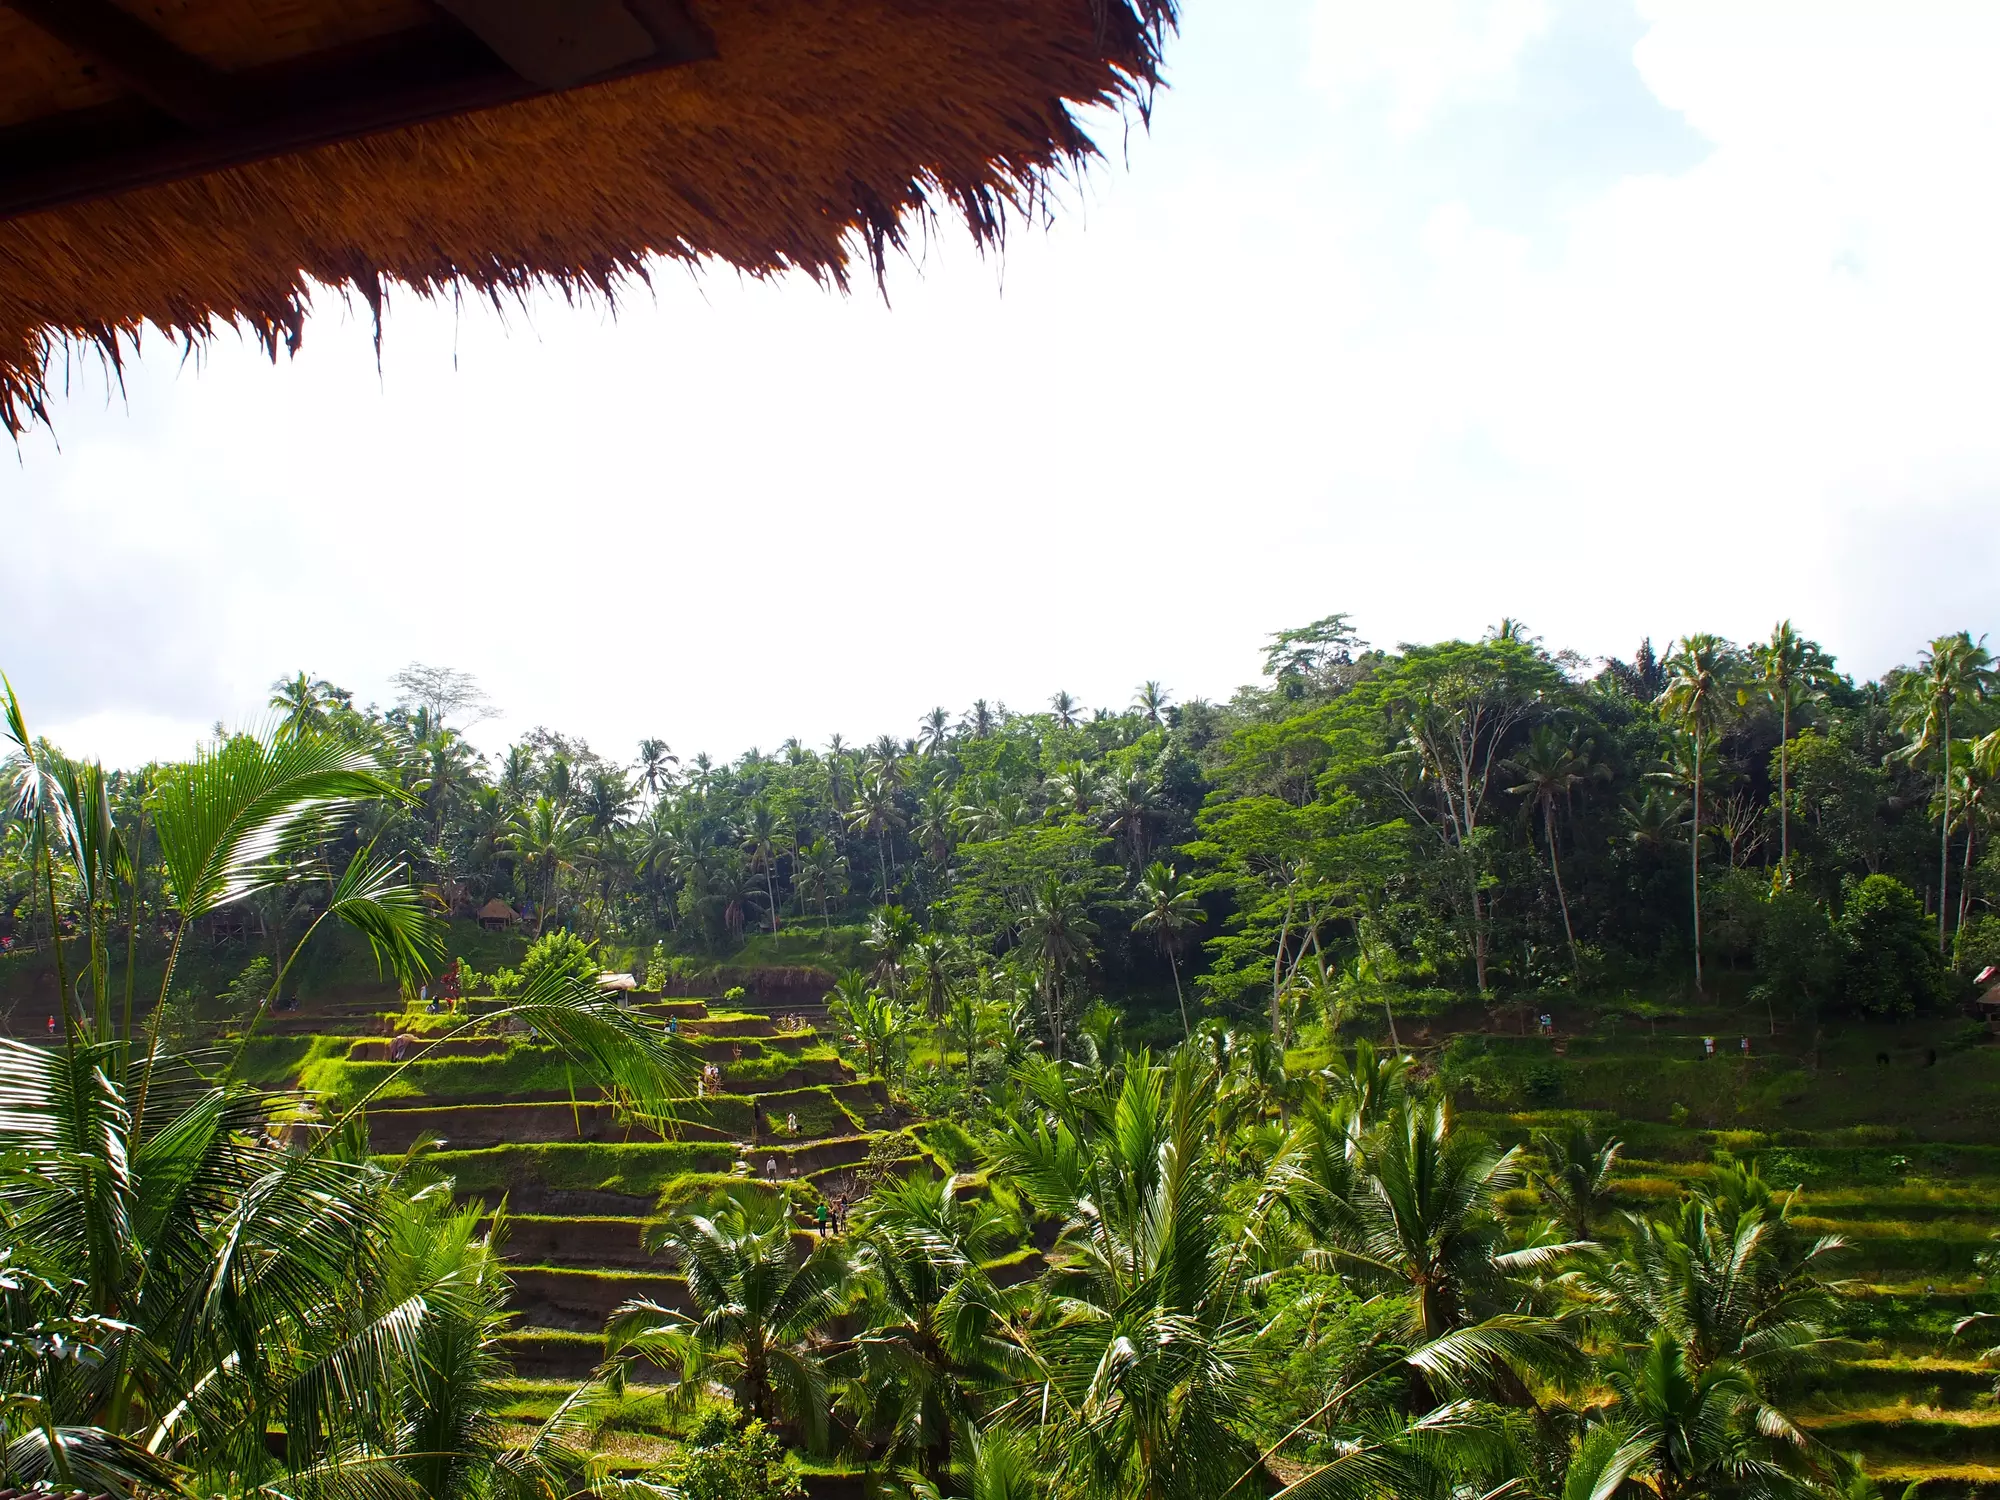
0, 0, 2000, 762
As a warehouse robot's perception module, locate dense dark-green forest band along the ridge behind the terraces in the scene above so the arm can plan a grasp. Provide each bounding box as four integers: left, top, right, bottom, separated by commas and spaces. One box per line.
0, 614, 2000, 1054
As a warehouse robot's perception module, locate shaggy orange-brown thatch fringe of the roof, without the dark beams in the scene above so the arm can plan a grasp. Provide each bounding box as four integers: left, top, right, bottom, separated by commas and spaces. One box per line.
0, 0, 1176, 438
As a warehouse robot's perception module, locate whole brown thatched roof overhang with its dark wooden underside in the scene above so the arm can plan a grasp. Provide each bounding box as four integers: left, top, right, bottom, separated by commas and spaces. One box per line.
0, 0, 1174, 432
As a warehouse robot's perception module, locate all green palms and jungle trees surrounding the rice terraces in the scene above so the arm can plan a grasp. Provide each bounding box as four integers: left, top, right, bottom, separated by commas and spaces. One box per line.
0, 616, 2000, 1500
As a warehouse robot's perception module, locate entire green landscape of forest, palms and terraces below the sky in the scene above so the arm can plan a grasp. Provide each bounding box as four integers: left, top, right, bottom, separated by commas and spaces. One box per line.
0, 616, 2000, 1498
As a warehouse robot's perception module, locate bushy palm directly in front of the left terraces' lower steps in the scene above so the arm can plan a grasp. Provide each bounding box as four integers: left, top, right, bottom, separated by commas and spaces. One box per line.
604, 1194, 848, 1444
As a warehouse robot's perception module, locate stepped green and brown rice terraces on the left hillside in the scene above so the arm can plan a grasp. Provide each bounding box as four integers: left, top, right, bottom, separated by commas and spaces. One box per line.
260, 996, 924, 1382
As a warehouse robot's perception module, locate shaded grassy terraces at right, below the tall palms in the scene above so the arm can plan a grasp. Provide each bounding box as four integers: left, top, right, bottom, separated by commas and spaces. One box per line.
1456, 1014, 2000, 1500
